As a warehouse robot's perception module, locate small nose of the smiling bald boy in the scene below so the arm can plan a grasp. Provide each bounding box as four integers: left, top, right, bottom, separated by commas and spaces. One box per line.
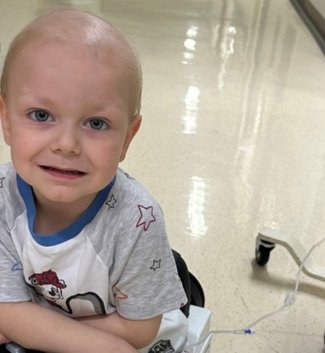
51, 126, 81, 155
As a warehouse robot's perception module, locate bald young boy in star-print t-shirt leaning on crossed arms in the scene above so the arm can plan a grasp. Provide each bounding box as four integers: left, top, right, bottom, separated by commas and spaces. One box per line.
0, 10, 187, 353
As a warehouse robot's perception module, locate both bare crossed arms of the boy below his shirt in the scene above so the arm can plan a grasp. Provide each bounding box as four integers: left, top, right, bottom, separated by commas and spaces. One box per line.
0, 302, 161, 353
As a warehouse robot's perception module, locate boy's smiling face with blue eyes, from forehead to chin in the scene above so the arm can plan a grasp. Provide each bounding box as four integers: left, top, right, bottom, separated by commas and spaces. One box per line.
0, 43, 141, 207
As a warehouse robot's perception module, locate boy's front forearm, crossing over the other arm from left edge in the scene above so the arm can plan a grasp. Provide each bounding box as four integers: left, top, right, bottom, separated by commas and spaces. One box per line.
0, 302, 137, 353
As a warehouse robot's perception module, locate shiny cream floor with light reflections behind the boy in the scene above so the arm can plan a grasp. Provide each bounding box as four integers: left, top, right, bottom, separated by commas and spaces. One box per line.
0, 0, 325, 353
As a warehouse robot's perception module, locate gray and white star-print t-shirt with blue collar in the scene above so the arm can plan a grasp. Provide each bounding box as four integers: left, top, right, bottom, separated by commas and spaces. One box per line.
0, 164, 187, 319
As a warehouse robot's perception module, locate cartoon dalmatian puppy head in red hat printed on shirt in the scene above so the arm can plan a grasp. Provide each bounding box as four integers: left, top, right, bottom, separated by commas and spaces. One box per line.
28, 270, 66, 303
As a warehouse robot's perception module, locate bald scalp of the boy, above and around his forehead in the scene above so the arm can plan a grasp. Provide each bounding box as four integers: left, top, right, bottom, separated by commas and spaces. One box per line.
0, 10, 142, 115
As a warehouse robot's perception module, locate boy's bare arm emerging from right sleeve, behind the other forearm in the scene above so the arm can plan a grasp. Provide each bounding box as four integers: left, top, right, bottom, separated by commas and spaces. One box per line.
77, 313, 162, 349
